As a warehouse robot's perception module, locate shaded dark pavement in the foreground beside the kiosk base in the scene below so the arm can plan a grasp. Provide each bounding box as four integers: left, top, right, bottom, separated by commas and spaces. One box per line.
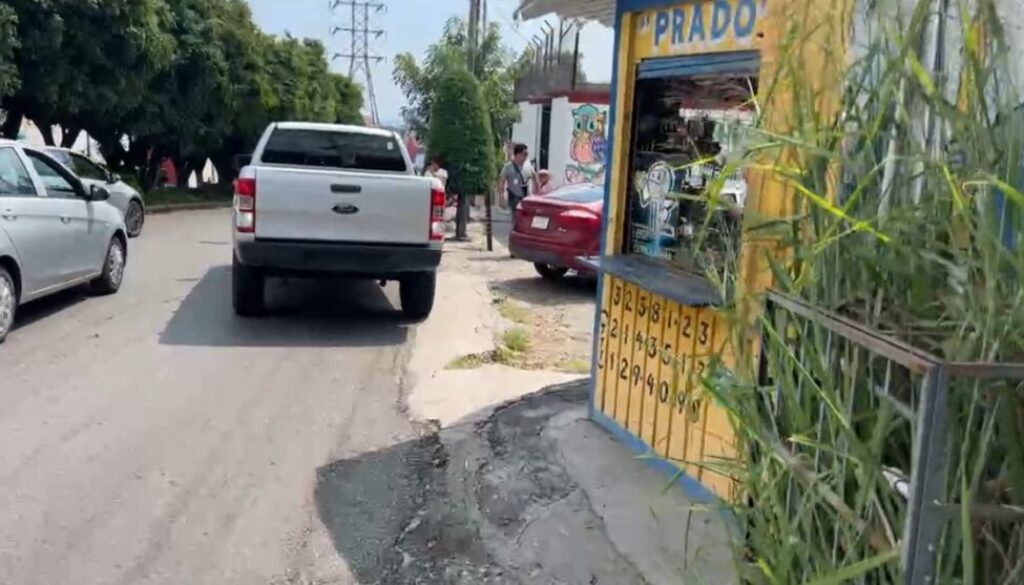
316, 380, 736, 585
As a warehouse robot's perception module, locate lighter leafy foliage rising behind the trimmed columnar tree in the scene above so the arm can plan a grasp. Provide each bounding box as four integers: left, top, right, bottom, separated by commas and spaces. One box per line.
393, 18, 523, 145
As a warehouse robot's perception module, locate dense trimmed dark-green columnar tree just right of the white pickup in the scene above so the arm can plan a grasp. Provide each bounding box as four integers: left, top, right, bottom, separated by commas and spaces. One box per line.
427, 65, 495, 195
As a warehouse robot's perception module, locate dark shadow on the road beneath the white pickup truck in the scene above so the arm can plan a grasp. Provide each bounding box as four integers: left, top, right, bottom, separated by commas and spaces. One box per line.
160, 266, 409, 347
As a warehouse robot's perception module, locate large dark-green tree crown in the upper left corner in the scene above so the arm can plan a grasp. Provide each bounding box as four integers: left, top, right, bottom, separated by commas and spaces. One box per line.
3, 0, 174, 142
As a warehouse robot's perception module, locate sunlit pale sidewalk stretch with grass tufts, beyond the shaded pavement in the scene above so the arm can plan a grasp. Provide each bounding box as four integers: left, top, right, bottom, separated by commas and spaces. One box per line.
407, 215, 596, 426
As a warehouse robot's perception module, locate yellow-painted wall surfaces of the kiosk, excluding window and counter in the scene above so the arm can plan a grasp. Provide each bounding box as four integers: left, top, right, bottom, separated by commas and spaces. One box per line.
594, 0, 849, 499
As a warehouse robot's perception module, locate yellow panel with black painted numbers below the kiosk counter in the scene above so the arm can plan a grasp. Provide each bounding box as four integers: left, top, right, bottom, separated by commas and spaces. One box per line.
593, 276, 735, 498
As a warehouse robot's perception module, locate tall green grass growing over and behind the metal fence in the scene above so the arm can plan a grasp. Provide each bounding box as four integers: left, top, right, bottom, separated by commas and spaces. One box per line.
705, 0, 1024, 585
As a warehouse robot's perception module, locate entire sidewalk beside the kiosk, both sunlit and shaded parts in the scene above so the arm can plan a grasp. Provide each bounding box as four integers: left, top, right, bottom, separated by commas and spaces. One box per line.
308, 223, 737, 585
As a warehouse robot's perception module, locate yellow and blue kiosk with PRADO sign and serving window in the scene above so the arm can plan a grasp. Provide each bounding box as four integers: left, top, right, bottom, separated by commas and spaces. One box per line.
591, 0, 781, 500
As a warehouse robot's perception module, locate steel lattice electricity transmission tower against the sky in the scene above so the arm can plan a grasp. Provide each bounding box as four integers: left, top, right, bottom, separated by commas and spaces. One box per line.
331, 0, 387, 125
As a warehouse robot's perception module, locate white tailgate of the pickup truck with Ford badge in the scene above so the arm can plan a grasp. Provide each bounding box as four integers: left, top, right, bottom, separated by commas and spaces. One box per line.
256, 166, 431, 245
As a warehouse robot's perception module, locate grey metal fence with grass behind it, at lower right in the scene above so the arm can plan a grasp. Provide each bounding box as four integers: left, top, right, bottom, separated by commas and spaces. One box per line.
761, 292, 1024, 585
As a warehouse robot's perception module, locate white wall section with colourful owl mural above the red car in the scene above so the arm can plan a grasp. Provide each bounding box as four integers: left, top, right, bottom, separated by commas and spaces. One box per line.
548, 97, 608, 185
